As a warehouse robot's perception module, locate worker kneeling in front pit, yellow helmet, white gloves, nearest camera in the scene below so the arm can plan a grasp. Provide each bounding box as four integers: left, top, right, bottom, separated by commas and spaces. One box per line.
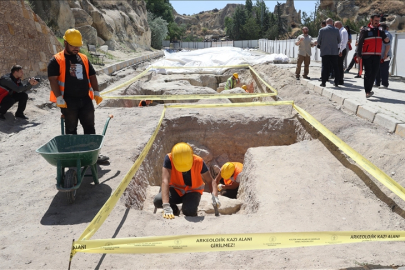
153, 142, 221, 219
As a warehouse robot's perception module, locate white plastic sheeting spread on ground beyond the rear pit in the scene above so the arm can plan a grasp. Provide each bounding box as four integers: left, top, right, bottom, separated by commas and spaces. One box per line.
152, 47, 289, 74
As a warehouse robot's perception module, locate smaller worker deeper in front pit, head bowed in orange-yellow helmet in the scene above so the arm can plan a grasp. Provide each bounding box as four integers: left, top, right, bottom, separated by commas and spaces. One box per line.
215, 162, 243, 199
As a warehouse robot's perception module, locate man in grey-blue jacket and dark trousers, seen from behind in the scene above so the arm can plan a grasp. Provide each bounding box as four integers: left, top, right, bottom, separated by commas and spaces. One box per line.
318, 18, 341, 87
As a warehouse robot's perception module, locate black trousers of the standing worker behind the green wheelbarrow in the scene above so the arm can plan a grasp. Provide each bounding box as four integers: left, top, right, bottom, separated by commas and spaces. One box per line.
61, 96, 96, 134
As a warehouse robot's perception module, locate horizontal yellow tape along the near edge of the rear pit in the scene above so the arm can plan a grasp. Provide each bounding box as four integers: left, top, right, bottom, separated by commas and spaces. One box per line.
103, 93, 276, 100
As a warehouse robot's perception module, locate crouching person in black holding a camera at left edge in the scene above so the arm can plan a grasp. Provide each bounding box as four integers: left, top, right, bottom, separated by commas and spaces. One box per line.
0, 65, 38, 120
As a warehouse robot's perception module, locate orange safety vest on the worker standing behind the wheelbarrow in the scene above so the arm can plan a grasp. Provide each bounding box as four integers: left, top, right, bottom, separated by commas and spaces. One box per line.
49, 51, 94, 102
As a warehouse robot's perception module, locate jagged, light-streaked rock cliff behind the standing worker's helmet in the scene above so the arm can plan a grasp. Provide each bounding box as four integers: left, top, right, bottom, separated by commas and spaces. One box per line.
30, 0, 151, 50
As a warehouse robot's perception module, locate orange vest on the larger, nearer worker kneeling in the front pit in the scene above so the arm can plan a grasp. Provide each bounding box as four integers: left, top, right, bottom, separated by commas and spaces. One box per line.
168, 154, 205, 196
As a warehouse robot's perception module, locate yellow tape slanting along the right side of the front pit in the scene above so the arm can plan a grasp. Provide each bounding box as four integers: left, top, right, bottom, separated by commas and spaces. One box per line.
293, 104, 405, 201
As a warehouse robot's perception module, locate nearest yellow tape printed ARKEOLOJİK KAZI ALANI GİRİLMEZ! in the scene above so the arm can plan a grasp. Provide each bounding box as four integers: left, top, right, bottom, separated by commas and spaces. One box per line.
73, 231, 405, 253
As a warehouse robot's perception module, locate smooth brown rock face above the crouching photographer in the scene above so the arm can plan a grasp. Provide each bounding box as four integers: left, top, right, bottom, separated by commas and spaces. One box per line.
0, 0, 62, 77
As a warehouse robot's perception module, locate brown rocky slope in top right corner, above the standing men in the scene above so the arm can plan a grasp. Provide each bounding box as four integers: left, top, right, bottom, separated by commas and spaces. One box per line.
319, 0, 405, 30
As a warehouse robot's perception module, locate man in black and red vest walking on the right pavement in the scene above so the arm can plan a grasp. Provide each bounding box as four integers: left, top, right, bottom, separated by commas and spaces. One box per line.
357, 15, 390, 98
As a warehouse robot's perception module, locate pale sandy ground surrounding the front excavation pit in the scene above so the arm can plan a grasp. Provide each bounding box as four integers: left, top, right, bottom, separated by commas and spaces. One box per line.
0, 59, 405, 269
